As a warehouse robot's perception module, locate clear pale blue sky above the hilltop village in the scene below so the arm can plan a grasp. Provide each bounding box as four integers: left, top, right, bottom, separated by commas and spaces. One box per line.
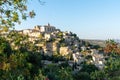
15, 0, 120, 39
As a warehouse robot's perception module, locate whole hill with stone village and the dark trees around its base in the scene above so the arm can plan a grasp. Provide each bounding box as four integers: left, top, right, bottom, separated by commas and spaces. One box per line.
0, 23, 120, 80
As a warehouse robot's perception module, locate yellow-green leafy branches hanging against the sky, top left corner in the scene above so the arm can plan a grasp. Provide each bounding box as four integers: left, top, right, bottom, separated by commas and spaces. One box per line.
0, 0, 35, 31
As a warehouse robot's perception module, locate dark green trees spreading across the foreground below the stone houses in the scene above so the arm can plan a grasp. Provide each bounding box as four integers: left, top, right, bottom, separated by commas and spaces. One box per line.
0, 31, 120, 80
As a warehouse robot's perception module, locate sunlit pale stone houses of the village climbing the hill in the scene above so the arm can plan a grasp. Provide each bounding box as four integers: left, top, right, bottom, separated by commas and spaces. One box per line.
9, 23, 104, 70
